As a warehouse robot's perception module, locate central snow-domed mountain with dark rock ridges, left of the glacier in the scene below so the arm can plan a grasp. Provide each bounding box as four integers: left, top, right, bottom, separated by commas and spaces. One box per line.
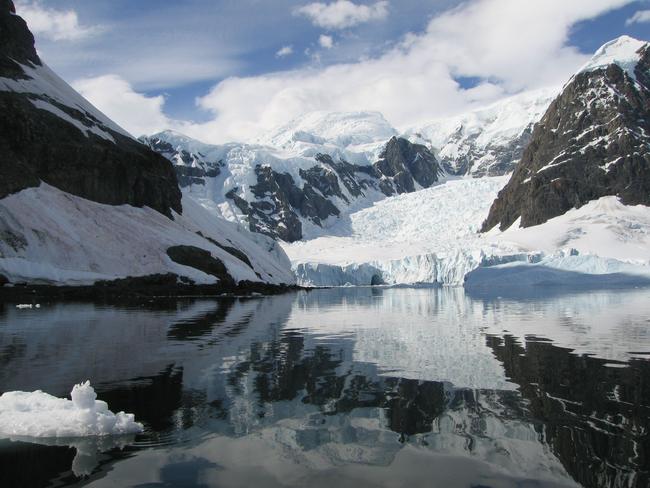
141, 124, 442, 242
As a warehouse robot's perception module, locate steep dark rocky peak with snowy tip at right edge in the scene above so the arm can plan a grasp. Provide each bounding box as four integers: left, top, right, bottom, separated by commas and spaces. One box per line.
483, 37, 650, 231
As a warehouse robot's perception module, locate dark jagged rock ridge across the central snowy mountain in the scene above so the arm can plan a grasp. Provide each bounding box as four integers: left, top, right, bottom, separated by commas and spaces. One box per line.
226, 138, 441, 242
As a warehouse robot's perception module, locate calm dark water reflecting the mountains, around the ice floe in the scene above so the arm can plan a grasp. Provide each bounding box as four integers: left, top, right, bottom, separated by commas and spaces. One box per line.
0, 289, 650, 488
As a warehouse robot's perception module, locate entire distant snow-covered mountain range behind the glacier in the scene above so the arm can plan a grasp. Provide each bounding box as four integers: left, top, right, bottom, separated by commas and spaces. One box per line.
141, 90, 555, 242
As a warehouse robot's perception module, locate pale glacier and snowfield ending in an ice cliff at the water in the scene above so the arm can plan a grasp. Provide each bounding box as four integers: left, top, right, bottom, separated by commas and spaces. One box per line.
285, 177, 650, 288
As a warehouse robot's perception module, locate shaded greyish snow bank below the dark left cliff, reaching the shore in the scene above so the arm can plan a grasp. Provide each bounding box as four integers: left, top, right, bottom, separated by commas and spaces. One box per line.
0, 183, 294, 285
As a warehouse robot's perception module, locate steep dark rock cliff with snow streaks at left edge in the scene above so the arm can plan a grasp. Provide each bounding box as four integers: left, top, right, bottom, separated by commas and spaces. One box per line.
0, 1, 182, 217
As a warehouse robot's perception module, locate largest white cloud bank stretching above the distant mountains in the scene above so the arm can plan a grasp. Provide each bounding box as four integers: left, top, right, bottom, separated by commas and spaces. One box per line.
73, 0, 632, 143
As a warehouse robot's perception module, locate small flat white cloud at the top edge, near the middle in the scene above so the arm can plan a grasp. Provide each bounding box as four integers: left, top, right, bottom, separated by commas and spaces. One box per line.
295, 0, 388, 29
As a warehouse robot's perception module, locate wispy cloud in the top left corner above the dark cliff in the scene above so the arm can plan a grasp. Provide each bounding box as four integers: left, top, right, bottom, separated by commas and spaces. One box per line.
16, 0, 100, 41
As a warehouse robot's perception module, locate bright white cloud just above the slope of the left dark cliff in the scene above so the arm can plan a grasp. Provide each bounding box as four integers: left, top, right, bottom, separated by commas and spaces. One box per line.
73, 75, 175, 137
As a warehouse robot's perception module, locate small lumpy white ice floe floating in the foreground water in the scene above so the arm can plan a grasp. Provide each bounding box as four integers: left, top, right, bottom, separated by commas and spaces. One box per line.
0, 381, 143, 438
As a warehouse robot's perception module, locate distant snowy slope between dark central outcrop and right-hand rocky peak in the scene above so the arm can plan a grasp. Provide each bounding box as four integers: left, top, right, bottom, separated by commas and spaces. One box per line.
406, 89, 559, 177
